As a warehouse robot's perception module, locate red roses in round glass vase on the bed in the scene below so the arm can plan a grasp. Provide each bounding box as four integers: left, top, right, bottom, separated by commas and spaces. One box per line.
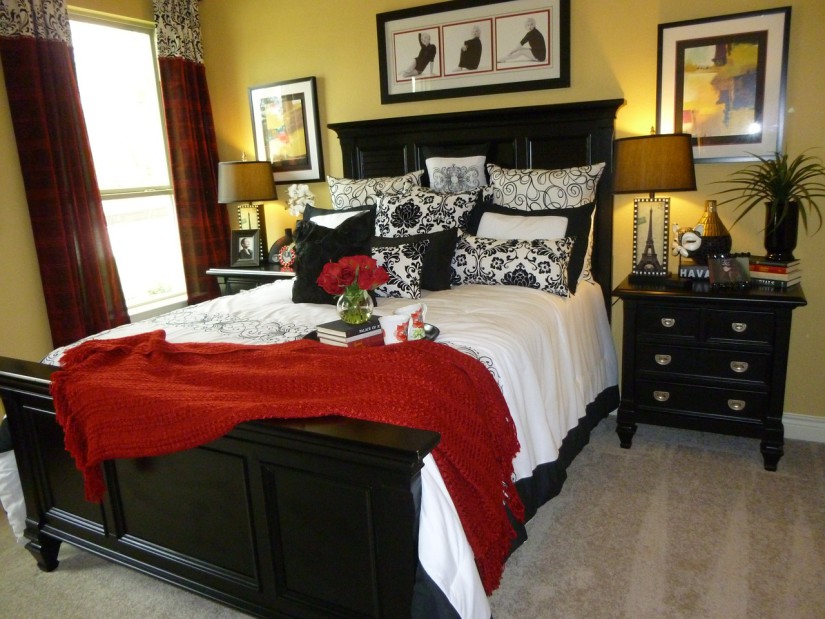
317, 256, 389, 324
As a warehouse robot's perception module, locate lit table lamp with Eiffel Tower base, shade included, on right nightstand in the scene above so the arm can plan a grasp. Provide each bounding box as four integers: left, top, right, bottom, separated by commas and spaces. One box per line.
613, 133, 696, 283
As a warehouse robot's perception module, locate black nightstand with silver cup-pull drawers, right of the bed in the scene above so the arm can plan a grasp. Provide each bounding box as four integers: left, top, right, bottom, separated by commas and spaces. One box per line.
613, 280, 807, 471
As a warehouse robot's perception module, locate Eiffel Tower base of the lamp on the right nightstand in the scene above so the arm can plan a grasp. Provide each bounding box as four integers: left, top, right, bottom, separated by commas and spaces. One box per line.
631, 198, 670, 281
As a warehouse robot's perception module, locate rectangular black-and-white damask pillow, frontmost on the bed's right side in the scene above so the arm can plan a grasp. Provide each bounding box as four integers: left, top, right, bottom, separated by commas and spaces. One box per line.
453, 232, 574, 297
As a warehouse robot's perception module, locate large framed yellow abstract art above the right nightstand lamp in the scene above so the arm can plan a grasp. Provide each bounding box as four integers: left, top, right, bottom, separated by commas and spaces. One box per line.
656, 7, 791, 163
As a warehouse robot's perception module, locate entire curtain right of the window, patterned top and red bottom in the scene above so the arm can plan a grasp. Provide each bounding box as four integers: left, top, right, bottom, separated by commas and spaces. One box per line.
154, 0, 229, 303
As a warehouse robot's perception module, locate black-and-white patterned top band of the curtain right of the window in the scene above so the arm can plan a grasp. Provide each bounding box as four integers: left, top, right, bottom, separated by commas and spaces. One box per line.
153, 0, 203, 64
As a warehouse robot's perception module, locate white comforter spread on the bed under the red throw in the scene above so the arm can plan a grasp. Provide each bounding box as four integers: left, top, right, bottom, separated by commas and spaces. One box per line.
44, 280, 618, 619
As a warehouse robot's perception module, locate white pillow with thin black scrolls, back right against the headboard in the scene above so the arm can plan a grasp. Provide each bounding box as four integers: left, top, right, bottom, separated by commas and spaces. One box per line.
487, 163, 604, 211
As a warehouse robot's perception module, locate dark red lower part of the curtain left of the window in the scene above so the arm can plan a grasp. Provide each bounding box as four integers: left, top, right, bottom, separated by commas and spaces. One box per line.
0, 36, 129, 346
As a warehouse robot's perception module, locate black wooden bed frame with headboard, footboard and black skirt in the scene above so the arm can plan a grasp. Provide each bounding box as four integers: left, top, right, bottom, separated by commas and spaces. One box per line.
0, 100, 622, 617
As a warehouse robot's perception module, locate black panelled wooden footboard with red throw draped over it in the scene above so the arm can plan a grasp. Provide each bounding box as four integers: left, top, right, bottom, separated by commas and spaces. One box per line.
0, 357, 438, 617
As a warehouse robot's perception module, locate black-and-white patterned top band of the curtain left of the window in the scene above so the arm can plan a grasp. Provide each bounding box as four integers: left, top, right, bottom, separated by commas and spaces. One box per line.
0, 0, 72, 45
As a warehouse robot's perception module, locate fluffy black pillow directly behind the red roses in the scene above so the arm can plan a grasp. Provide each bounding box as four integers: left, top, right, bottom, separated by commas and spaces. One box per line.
292, 209, 375, 305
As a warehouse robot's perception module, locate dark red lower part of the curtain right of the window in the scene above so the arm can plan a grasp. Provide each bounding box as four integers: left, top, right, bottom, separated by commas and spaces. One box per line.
159, 57, 229, 303
